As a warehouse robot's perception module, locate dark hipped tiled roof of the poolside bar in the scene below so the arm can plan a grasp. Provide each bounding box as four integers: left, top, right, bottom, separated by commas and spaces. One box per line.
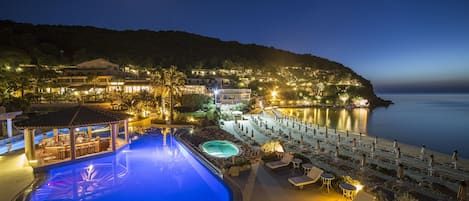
15, 106, 130, 129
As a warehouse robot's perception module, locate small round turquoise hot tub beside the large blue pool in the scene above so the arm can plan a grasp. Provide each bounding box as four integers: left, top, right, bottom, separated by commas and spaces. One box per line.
202, 140, 239, 158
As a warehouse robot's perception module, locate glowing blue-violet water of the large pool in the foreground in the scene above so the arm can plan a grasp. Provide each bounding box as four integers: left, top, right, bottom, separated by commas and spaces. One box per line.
32, 134, 231, 201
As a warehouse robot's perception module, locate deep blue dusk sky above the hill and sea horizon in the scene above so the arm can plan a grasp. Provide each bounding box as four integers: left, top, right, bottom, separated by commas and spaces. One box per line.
0, 0, 469, 92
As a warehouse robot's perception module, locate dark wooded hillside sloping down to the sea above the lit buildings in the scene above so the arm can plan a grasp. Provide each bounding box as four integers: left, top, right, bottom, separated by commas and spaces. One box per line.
0, 21, 385, 105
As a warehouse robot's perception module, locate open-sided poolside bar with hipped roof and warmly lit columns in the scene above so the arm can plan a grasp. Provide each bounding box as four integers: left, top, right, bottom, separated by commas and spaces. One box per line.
16, 106, 129, 167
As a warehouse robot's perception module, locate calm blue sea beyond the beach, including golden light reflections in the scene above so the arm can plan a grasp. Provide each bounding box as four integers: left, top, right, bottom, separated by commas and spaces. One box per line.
281, 94, 469, 159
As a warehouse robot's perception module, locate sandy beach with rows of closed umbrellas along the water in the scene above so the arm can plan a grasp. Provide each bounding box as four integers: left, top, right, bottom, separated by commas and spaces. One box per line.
223, 110, 469, 200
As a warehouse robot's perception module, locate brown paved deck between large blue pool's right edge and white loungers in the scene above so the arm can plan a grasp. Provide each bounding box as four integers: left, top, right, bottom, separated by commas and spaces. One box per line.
225, 162, 344, 201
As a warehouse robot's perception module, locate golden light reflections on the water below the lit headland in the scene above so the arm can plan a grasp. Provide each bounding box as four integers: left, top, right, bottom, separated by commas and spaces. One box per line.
279, 108, 369, 134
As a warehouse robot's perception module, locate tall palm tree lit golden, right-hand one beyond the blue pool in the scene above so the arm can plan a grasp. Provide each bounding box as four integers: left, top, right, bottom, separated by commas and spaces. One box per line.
162, 66, 186, 124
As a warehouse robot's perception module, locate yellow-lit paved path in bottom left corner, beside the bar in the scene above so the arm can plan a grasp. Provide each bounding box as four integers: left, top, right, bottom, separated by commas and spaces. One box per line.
0, 151, 34, 201
